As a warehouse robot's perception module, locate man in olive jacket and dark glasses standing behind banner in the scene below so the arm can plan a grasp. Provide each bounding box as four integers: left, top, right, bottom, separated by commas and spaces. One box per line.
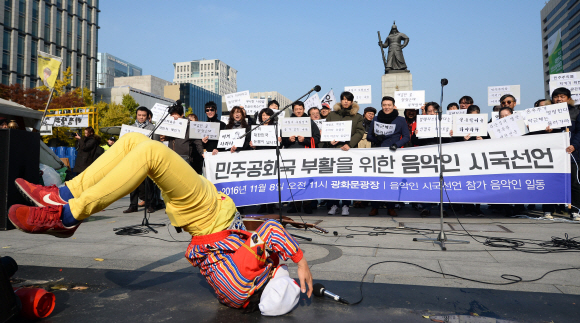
322, 91, 365, 216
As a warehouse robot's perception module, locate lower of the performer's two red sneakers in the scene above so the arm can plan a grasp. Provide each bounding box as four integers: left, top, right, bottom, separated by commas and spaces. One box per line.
8, 204, 80, 238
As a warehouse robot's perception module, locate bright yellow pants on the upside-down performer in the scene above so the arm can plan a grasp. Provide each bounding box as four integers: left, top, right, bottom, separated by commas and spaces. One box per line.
66, 133, 236, 235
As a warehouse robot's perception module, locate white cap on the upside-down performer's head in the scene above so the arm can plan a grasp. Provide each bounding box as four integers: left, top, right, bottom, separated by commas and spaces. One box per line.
259, 265, 300, 316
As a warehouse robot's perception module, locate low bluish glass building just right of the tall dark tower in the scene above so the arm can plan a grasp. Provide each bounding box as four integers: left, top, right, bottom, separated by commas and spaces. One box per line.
97, 53, 143, 88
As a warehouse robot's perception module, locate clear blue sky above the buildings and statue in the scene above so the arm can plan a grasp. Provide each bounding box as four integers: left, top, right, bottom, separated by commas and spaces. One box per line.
99, 0, 545, 112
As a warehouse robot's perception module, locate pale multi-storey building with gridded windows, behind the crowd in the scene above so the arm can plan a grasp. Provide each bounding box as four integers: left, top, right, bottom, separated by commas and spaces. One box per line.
173, 59, 238, 96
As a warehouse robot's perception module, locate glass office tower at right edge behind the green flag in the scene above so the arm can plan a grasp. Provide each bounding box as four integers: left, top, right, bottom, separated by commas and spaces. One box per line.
540, 0, 580, 97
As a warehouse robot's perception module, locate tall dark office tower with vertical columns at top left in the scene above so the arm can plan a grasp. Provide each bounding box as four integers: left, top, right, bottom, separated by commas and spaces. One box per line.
0, 0, 100, 91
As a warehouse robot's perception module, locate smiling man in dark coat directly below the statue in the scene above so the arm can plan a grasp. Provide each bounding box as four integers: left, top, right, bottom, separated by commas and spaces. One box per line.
367, 96, 410, 216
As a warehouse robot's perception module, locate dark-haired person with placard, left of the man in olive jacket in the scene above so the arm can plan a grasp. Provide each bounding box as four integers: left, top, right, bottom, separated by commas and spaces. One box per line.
282, 101, 320, 214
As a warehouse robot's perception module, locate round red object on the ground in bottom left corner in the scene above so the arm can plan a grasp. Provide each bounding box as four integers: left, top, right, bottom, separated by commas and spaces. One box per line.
14, 288, 55, 319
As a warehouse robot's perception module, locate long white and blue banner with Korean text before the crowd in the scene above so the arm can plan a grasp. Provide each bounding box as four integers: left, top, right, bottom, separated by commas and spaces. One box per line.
205, 132, 571, 206
